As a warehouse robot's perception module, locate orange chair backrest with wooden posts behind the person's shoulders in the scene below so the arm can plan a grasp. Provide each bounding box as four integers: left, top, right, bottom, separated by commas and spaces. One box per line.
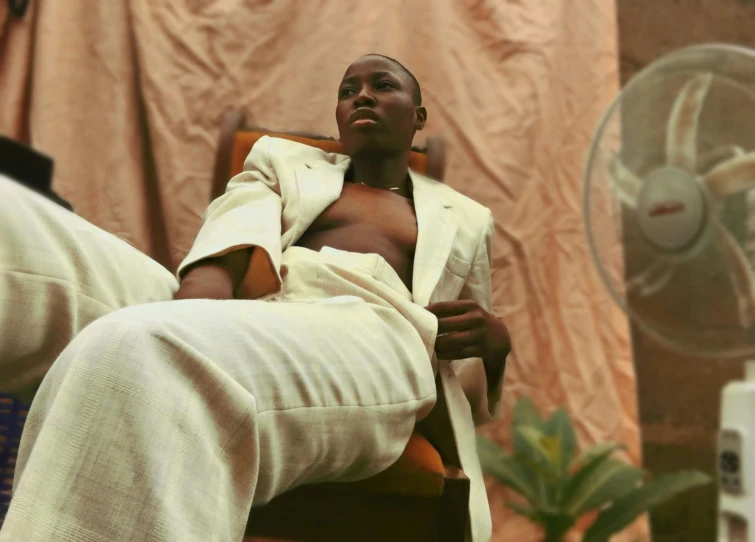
210, 111, 446, 201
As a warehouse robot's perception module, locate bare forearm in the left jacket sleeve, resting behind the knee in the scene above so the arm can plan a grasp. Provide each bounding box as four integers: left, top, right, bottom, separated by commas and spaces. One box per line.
173, 249, 251, 300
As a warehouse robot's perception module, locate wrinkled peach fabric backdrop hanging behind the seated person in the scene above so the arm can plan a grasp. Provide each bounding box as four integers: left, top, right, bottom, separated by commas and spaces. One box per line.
0, 0, 647, 542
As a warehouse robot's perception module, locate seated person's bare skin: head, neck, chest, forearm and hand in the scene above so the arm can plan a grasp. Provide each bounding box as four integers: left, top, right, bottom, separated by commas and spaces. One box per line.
176, 55, 511, 382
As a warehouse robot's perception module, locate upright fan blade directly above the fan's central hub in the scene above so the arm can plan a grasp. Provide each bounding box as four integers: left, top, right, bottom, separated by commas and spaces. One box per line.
666, 73, 713, 172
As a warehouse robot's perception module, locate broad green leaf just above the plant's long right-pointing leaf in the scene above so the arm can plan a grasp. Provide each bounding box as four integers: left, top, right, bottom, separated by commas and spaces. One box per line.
563, 457, 645, 517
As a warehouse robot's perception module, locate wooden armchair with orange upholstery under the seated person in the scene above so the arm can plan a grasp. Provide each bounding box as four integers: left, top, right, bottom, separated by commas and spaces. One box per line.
212, 112, 469, 542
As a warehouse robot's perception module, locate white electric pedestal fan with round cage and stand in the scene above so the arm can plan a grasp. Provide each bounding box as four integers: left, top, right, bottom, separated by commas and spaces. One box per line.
584, 45, 755, 542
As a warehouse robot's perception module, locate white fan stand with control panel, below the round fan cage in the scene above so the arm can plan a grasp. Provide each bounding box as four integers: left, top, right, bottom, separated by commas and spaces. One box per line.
718, 360, 755, 542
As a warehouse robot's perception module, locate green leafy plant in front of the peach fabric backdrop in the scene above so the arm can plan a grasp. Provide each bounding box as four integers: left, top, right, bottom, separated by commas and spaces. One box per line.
477, 398, 711, 542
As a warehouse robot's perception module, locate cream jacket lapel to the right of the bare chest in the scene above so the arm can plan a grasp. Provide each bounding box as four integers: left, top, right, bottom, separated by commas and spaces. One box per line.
411, 174, 459, 307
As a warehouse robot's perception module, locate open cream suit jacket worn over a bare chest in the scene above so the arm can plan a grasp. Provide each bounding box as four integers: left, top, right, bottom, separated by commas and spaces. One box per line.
178, 136, 502, 540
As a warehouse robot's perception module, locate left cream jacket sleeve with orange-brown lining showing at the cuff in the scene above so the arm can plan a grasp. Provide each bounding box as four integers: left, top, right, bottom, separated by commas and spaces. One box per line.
177, 136, 284, 298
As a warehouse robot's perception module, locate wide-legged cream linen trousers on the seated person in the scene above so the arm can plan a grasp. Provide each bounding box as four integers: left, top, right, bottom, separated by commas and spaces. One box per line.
0, 177, 436, 542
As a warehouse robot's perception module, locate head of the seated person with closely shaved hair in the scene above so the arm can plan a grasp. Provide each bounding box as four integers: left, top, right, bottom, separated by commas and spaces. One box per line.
336, 56, 426, 155
